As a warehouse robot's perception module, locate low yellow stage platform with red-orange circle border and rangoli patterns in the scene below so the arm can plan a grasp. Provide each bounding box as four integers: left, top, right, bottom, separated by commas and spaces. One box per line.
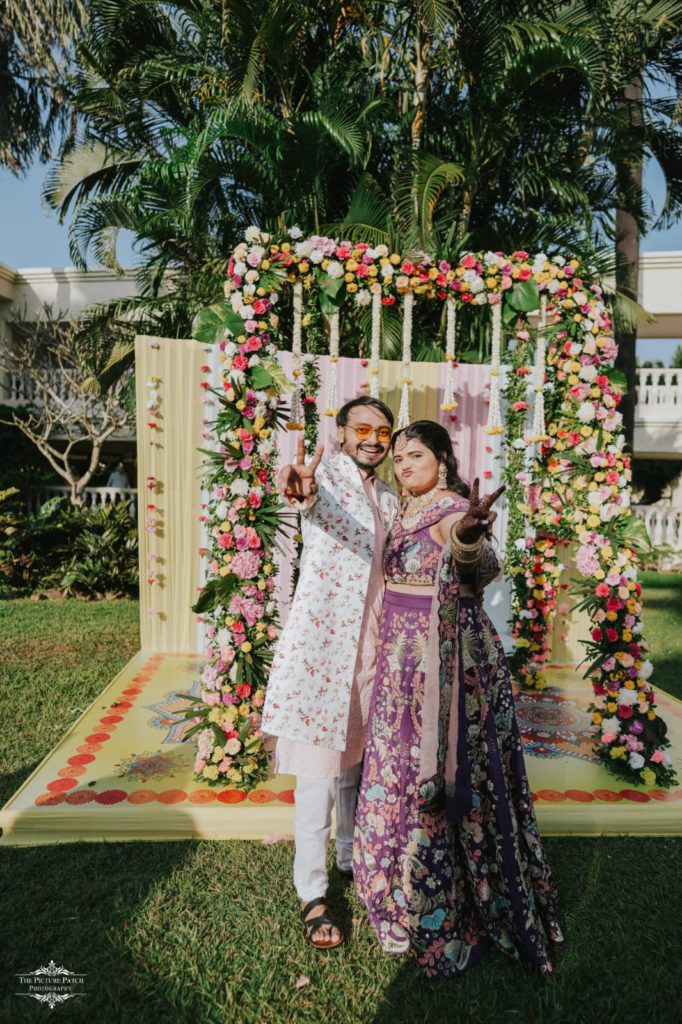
0, 652, 682, 846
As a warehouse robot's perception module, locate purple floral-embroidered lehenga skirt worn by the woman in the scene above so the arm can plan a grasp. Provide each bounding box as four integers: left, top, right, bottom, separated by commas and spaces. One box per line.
353, 590, 562, 978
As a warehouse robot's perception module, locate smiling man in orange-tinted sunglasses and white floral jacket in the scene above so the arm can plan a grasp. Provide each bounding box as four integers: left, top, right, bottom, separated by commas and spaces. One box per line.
262, 397, 398, 948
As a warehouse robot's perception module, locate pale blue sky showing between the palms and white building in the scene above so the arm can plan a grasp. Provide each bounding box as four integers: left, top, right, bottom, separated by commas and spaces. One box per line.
0, 149, 682, 365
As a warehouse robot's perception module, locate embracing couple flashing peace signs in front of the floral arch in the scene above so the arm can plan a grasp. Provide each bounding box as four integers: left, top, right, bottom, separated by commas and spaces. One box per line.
262, 397, 561, 978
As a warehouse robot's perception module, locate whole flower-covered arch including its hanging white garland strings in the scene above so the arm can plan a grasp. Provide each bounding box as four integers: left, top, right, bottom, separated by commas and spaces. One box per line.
180, 227, 674, 790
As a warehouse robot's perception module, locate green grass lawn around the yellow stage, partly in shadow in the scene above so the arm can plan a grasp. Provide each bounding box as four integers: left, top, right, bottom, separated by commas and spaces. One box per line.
0, 574, 682, 1024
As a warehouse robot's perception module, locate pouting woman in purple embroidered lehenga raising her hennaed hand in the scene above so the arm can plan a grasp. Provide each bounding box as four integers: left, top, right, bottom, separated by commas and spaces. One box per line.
353, 420, 561, 978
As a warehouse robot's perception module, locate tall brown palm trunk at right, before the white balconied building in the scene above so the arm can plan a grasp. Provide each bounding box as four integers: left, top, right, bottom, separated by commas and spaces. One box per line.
615, 77, 643, 452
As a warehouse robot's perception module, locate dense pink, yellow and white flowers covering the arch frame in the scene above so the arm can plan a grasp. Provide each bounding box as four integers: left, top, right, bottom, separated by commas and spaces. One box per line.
188, 227, 673, 787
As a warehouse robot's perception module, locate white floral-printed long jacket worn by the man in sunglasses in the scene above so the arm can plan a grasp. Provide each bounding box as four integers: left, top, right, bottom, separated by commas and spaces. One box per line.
262, 453, 398, 761
